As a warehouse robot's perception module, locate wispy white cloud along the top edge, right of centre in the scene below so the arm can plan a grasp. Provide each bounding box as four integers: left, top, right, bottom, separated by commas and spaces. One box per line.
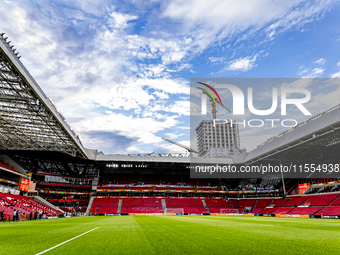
162, 0, 334, 51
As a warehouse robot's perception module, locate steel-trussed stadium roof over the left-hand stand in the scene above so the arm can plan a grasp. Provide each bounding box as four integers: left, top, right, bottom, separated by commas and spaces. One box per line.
0, 34, 87, 158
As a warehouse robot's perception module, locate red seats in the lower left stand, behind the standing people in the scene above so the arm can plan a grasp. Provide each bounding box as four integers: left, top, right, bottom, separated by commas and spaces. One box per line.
0, 193, 61, 215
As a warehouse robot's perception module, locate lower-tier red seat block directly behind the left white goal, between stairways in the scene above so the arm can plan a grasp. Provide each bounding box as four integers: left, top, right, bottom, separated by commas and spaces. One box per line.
165, 198, 207, 213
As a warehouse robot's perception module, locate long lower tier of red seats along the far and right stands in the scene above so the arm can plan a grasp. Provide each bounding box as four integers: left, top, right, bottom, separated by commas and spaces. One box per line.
87, 192, 340, 215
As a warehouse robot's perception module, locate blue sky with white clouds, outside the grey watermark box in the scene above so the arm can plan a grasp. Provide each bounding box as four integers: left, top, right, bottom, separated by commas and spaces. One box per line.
0, 0, 340, 153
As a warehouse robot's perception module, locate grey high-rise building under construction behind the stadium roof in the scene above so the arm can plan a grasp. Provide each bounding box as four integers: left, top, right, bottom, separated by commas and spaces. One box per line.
196, 120, 241, 158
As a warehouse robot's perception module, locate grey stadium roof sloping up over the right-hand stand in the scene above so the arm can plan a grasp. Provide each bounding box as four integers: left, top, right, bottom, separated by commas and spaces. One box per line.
245, 105, 340, 164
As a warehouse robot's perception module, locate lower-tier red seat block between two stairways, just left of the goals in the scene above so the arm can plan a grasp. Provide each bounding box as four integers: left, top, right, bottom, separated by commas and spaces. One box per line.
121, 198, 163, 213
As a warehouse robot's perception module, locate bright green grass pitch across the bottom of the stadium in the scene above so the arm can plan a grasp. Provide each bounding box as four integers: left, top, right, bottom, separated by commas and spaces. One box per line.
0, 216, 340, 255
